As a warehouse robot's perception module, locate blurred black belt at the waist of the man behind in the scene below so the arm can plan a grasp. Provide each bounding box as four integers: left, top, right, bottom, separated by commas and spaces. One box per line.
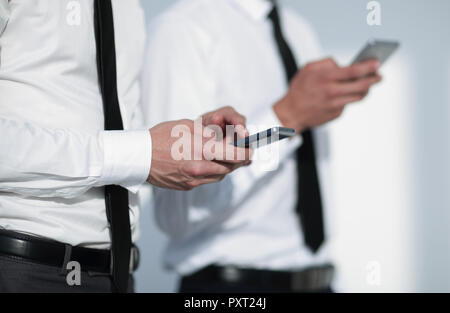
184, 264, 334, 292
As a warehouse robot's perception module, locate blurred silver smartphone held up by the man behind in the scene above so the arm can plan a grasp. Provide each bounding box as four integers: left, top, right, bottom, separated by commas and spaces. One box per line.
352, 39, 400, 64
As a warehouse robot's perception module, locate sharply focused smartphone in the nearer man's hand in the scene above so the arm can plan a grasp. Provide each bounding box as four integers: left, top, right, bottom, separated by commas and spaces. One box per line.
233, 127, 295, 149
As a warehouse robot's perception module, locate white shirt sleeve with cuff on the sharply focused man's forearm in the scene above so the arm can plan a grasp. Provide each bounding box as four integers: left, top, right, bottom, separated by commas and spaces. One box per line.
0, 117, 151, 198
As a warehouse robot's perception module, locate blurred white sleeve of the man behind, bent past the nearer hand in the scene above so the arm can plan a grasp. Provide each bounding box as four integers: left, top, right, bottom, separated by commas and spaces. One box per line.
142, 15, 301, 238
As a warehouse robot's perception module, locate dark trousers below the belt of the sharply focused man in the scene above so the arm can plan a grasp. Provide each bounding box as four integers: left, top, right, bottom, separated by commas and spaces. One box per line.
0, 255, 134, 293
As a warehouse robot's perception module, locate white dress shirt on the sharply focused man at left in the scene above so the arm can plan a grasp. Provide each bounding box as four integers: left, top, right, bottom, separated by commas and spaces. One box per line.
0, 0, 151, 248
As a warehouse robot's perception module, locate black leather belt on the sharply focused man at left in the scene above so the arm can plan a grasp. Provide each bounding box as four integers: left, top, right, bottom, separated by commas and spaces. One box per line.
0, 230, 139, 274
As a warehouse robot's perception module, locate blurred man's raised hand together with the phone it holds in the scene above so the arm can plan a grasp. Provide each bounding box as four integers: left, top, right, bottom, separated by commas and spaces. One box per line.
268, 40, 400, 132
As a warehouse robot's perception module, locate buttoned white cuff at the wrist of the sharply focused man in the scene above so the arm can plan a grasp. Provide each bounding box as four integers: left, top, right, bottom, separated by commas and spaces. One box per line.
100, 130, 152, 193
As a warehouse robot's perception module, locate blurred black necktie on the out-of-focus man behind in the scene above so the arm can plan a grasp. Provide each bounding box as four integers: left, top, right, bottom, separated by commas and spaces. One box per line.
269, 6, 325, 253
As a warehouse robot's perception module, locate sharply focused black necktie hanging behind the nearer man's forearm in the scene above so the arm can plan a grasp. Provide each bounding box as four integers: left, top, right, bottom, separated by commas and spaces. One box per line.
94, 0, 131, 292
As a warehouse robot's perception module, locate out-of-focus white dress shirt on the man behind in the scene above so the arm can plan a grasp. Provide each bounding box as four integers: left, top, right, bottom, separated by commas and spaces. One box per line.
143, 0, 330, 274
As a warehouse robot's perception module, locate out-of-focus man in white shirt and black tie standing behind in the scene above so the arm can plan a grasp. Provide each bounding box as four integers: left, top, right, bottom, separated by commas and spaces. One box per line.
143, 0, 381, 292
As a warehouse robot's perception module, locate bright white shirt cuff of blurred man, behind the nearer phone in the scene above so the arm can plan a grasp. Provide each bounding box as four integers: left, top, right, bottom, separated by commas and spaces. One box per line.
248, 107, 303, 178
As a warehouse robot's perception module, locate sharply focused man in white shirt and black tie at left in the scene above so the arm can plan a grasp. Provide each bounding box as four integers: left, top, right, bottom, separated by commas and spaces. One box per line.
0, 0, 249, 292
